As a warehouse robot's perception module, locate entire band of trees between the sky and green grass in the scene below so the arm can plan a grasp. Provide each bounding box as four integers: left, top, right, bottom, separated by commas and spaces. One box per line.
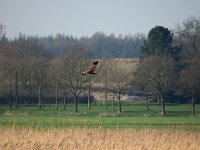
0, 17, 200, 115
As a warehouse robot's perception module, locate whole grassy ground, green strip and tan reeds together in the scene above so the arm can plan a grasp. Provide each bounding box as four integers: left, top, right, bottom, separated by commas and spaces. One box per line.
0, 102, 200, 150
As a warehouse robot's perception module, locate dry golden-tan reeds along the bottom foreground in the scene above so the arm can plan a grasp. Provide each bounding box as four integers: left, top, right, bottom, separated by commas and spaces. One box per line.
0, 128, 200, 150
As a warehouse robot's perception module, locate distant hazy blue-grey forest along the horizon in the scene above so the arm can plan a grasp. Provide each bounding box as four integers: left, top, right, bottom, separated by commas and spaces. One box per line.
4, 32, 146, 58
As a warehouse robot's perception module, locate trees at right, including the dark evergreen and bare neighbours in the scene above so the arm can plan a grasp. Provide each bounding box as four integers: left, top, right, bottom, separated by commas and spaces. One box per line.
135, 17, 200, 115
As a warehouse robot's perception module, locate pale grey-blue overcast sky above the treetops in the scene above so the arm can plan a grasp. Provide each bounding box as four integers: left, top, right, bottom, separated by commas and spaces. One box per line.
0, 0, 200, 38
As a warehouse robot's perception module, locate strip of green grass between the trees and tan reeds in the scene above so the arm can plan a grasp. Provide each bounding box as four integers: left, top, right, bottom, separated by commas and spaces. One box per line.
0, 103, 200, 131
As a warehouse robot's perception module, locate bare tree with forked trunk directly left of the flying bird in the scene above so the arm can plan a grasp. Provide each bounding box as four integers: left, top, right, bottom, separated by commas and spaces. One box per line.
60, 44, 90, 113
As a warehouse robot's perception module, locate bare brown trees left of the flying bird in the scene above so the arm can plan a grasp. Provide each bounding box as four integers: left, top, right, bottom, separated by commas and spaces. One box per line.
0, 31, 89, 112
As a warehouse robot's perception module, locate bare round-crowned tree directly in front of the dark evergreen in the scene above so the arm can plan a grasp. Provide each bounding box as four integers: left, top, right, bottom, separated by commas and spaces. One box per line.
135, 56, 175, 115
